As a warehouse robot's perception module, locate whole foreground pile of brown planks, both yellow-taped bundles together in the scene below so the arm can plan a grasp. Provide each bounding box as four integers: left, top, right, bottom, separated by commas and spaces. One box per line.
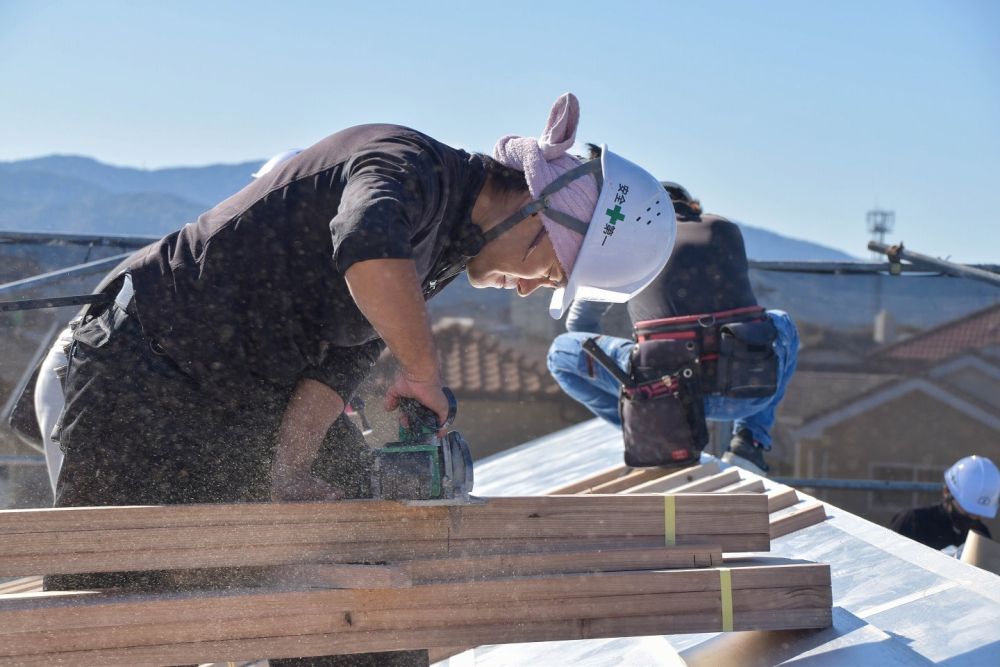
0, 475, 831, 665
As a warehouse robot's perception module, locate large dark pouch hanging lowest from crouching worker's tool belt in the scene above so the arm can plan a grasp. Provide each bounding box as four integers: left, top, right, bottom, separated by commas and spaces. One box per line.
619, 367, 708, 467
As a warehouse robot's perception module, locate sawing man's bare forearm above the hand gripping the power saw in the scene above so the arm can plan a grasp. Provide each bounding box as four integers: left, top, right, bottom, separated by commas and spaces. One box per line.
344, 259, 439, 381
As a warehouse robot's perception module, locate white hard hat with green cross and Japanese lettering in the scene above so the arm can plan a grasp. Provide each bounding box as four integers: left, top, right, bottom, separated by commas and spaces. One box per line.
549, 146, 677, 319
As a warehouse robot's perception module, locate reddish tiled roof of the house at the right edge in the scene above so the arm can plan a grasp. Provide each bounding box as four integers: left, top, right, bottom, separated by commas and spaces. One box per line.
871, 304, 1000, 362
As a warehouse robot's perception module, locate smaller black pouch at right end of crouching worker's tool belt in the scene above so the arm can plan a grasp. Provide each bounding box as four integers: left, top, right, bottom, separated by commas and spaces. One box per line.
717, 318, 778, 398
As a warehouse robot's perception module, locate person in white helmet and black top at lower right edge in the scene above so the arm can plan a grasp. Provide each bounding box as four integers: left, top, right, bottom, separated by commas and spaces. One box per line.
889, 456, 1000, 551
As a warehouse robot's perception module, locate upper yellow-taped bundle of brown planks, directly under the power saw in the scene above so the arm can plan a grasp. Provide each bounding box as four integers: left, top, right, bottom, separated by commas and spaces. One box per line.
0, 494, 770, 576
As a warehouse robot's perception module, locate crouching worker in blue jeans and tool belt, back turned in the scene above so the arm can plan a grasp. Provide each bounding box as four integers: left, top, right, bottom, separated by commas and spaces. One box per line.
548, 175, 799, 474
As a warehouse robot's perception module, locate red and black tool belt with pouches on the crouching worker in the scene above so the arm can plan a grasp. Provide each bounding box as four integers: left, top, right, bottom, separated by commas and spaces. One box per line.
619, 306, 778, 466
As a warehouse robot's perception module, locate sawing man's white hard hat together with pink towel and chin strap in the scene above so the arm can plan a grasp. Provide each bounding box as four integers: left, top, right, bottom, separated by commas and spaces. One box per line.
485, 93, 677, 319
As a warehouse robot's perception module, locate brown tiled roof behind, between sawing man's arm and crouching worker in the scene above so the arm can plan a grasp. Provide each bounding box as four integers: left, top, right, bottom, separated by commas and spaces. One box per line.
376, 322, 564, 399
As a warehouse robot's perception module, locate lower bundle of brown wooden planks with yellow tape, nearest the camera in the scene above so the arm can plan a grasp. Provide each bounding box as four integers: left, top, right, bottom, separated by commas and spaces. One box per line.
0, 564, 830, 665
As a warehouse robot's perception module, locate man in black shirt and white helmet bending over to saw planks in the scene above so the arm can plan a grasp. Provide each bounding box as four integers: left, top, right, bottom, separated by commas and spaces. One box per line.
46, 94, 675, 665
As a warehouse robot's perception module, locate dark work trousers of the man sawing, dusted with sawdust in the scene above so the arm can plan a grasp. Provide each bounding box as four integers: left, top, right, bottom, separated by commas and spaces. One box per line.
44, 305, 428, 667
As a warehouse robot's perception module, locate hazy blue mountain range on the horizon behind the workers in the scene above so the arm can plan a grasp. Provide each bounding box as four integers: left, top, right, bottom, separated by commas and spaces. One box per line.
0, 155, 855, 261
